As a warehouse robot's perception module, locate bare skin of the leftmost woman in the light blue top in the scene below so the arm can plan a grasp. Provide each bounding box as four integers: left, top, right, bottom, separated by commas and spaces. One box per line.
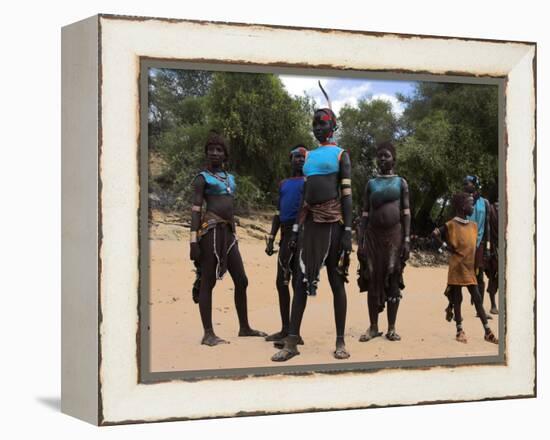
190, 144, 266, 346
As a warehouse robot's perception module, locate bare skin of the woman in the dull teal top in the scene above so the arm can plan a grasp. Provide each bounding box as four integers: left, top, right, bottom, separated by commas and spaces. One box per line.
357, 148, 411, 342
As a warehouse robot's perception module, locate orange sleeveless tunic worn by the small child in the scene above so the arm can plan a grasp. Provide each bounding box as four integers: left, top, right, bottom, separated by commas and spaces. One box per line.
445, 217, 477, 286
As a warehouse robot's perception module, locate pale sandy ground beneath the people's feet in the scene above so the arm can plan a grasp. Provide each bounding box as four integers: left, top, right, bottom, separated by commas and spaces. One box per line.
149, 215, 498, 372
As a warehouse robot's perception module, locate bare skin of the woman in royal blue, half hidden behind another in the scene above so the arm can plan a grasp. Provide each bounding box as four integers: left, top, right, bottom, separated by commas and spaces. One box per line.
265, 151, 306, 341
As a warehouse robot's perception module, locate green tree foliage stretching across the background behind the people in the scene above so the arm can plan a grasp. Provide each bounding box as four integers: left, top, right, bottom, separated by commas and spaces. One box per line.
149, 69, 498, 234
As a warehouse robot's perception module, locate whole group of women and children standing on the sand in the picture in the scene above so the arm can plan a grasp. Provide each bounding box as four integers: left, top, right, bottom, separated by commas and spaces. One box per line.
190, 102, 498, 362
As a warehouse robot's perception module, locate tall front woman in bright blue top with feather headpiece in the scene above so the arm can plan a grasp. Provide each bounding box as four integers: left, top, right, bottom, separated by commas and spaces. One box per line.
271, 105, 352, 362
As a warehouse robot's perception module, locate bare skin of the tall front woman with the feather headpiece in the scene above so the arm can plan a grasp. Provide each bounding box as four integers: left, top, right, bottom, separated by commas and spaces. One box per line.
271, 110, 352, 362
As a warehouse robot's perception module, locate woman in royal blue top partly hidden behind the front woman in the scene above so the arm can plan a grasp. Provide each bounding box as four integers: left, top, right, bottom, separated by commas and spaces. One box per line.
265, 144, 307, 348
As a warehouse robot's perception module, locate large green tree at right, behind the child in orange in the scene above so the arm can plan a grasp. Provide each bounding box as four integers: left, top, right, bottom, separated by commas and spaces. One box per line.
398, 83, 498, 234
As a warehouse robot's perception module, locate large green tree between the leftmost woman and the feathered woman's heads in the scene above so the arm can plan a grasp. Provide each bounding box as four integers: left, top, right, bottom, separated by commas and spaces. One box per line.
208, 73, 313, 201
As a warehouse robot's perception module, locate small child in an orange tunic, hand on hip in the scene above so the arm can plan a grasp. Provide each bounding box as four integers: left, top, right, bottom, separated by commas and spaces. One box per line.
432, 192, 498, 344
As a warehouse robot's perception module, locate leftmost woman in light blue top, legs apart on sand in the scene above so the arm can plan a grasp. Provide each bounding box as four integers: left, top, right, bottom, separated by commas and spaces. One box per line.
191, 133, 266, 346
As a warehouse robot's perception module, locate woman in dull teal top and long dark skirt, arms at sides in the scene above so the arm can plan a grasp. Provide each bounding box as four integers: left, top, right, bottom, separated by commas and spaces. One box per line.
357, 142, 411, 342
